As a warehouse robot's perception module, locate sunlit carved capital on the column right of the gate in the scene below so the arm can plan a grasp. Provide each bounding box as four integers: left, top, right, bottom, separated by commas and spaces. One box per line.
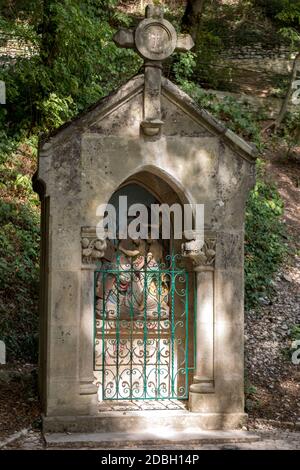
182, 237, 216, 268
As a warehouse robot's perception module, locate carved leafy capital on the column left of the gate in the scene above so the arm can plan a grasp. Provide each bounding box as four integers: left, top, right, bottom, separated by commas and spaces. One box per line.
81, 227, 107, 264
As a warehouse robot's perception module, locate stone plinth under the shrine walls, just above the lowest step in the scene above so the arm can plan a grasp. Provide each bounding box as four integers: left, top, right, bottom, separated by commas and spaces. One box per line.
43, 410, 247, 435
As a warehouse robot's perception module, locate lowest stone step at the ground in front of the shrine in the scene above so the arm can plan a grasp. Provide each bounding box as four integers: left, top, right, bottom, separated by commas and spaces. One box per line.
44, 430, 260, 449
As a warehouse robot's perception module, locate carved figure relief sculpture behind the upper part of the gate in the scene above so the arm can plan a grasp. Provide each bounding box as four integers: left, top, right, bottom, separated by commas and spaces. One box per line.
96, 239, 169, 319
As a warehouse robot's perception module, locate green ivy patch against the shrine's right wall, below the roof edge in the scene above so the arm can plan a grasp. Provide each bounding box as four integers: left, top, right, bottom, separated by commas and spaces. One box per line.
245, 164, 286, 308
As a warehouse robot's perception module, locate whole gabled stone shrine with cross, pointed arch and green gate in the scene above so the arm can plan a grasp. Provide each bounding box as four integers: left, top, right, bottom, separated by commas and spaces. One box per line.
34, 6, 256, 432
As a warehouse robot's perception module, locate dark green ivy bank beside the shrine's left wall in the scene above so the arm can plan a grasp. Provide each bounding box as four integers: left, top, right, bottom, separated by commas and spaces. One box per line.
0, 201, 39, 362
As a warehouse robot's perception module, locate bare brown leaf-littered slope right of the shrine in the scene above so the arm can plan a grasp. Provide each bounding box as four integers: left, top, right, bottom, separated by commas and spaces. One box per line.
245, 151, 300, 423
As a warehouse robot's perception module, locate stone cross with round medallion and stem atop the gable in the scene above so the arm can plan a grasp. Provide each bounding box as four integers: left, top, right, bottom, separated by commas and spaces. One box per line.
114, 5, 194, 136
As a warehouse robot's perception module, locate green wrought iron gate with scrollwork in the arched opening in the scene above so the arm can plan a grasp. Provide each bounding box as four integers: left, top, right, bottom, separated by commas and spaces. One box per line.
95, 255, 189, 400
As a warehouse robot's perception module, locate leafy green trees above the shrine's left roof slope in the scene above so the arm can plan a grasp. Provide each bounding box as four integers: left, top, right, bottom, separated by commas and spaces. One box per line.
0, 0, 141, 133
